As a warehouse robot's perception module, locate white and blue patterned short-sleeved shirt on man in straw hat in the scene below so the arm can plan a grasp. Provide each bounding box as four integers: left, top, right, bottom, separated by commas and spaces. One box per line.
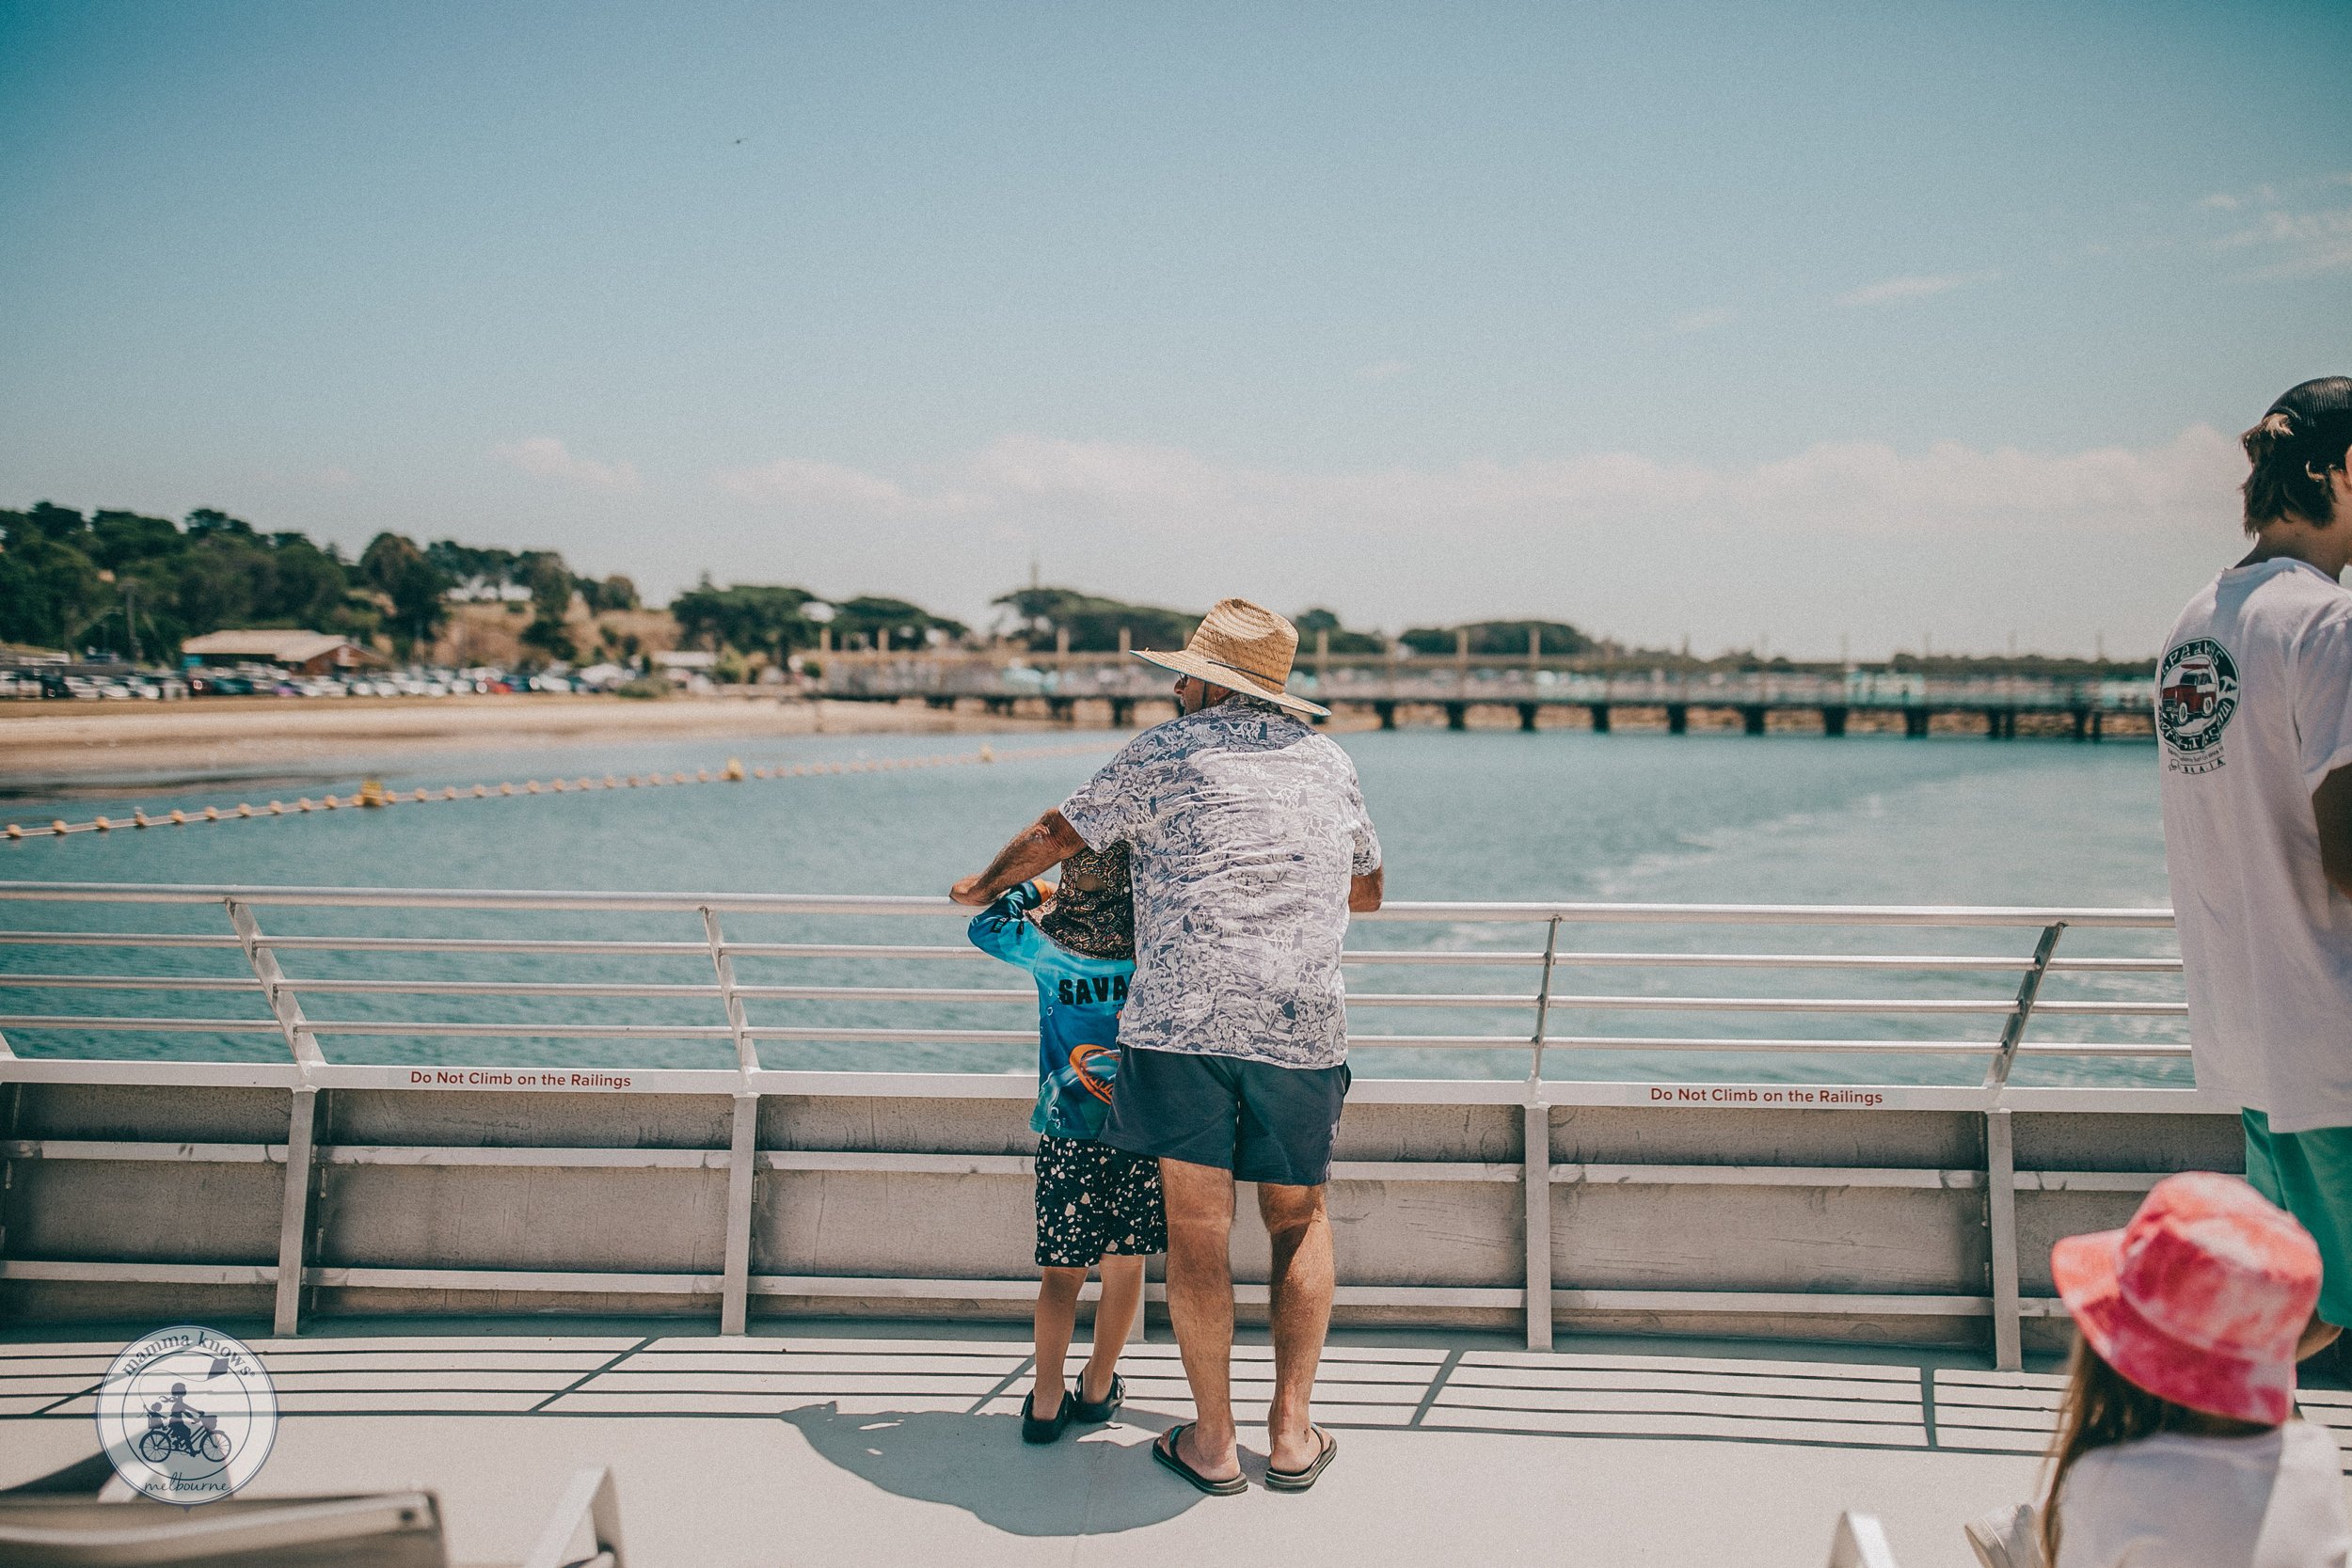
1061, 698, 1381, 1068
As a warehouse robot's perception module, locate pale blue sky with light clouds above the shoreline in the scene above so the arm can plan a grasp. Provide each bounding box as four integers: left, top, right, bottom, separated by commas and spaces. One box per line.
0, 0, 2352, 654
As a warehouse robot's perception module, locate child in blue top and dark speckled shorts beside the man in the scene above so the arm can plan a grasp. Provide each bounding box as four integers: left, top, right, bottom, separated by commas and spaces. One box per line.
972, 844, 1169, 1444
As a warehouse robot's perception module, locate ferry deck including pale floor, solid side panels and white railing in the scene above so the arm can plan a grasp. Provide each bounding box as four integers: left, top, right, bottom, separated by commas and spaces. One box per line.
0, 884, 2352, 1568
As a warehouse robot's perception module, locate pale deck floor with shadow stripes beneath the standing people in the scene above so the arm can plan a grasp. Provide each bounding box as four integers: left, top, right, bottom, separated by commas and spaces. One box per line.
18, 1323, 2352, 1568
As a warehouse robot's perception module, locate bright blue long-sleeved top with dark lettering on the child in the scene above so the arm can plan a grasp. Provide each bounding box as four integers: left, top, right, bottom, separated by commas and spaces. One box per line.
972, 881, 1136, 1138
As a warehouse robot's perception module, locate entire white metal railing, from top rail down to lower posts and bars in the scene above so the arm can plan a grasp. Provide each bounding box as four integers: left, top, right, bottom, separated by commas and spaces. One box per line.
0, 881, 2223, 1369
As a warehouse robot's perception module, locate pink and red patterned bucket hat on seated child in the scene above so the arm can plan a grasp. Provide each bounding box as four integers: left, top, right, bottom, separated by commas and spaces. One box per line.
2051, 1171, 2319, 1427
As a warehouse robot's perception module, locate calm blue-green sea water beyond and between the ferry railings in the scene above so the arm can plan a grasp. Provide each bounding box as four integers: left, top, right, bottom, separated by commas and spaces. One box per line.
0, 731, 2187, 1082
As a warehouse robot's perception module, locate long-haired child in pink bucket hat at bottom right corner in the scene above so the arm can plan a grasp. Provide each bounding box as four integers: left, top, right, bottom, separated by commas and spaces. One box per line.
2042, 1171, 2352, 1568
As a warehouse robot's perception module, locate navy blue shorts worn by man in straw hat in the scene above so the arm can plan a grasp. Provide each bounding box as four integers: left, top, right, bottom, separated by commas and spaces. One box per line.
1104, 1046, 1350, 1187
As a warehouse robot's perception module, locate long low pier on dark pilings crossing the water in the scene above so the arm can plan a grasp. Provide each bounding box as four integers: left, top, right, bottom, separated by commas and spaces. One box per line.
818, 654, 2154, 743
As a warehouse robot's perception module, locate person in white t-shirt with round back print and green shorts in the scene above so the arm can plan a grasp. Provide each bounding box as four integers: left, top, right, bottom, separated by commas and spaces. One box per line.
2157, 376, 2352, 1356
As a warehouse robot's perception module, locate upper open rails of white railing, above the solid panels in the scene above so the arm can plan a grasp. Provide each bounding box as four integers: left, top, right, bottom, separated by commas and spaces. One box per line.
0, 881, 2187, 1088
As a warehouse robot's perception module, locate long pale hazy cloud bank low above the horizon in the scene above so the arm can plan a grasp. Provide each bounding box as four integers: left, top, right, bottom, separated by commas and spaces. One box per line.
718, 425, 2244, 654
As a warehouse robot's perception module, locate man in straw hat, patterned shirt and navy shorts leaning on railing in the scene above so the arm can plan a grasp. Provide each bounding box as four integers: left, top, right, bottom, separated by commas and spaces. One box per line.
953, 599, 1381, 1496
